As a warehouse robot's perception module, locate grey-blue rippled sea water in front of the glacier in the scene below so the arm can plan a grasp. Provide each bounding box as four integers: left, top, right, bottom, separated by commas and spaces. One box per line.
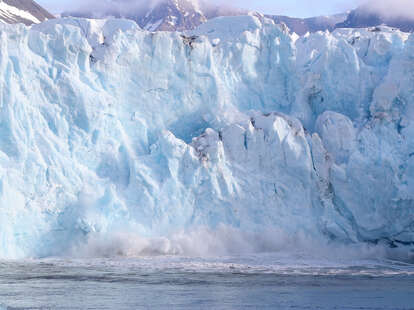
0, 254, 414, 310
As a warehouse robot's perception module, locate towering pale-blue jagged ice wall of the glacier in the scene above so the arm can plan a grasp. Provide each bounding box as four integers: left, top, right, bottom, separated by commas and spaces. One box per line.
0, 16, 414, 258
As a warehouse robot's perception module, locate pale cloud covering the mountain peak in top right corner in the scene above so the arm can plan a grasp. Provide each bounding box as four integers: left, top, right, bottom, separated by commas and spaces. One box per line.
361, 0, 414, 20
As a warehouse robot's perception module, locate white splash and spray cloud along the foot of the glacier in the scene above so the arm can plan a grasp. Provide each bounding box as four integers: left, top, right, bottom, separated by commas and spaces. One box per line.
68, 225, 414, 270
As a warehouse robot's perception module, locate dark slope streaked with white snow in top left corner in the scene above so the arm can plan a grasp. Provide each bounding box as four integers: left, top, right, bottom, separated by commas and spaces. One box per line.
0, 0, 54, 25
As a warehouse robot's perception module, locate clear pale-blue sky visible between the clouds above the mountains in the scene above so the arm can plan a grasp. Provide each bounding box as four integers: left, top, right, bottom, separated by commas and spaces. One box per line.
36, 0, 360, 17
